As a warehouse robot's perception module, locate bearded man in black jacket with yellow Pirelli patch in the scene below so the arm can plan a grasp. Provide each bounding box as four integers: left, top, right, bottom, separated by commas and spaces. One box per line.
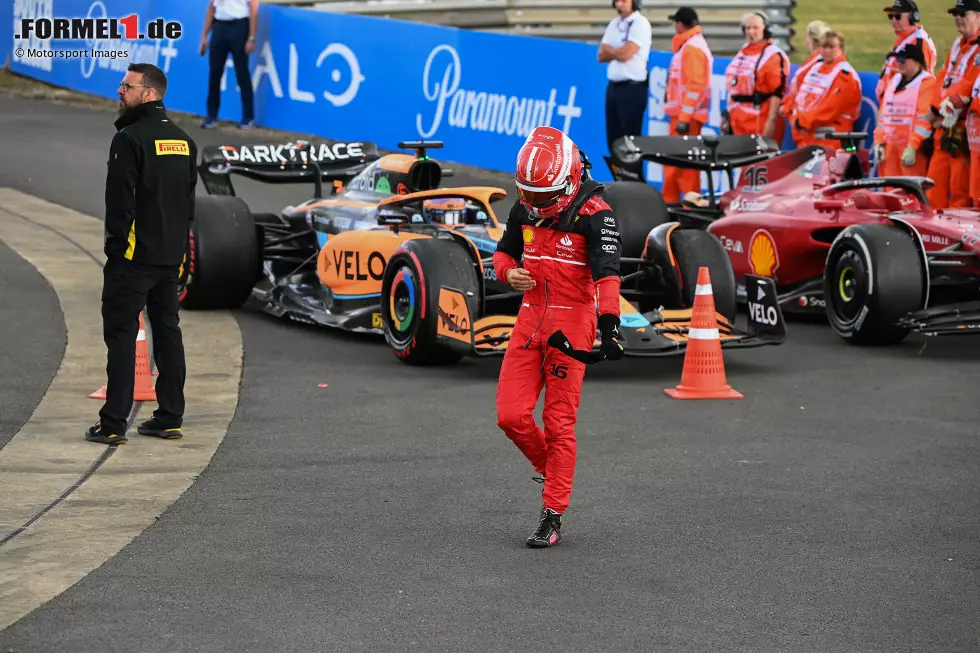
85, 63, 197, 445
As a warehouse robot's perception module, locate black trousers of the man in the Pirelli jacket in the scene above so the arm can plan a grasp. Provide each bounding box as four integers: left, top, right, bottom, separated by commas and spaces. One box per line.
99, 258, 187, 433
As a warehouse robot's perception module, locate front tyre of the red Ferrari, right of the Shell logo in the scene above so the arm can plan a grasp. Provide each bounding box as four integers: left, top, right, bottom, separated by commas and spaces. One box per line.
824, 224, 926, 345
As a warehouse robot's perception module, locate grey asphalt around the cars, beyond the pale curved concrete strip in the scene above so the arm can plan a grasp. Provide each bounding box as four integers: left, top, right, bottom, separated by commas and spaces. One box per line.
0, 93, 980, 652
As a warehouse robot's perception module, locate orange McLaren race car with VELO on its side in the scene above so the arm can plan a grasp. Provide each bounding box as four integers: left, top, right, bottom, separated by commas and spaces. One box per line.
181, 142, 785, 363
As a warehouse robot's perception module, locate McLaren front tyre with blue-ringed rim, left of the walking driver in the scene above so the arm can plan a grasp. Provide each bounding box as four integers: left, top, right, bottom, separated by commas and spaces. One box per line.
381, 238, 481, 365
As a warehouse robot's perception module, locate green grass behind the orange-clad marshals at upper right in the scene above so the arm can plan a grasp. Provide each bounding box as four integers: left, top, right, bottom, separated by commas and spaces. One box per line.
792, 0, 958, 73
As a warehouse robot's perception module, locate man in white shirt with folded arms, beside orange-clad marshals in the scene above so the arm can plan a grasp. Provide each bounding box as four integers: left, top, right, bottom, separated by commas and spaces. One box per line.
599, 0, 653, 152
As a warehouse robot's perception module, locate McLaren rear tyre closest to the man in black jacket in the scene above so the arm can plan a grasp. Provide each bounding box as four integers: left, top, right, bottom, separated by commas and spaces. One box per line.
180, 196, 262, 309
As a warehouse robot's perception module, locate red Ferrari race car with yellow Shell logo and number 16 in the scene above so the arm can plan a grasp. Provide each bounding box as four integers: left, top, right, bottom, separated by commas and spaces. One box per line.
607, 133, 980, 344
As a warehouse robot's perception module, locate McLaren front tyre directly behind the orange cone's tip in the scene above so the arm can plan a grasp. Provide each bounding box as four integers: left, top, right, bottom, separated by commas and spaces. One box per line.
670, 229, 737, 323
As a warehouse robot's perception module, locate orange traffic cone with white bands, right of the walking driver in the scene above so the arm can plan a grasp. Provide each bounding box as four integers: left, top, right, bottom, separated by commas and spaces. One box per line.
664, 267, 743, 399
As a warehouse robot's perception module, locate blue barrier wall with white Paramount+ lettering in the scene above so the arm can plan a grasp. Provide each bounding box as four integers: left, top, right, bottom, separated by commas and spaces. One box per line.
7, 0, 877, 190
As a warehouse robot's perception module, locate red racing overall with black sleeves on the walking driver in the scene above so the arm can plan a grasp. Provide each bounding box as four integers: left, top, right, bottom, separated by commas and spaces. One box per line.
493, 181, 621, 514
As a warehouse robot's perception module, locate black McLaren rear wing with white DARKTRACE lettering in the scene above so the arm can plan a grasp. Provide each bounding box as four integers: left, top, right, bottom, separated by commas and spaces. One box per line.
198, 141, 380, 197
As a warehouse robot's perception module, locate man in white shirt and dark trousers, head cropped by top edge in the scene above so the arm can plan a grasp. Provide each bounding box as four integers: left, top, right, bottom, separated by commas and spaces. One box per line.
201, 0, 259, 129
